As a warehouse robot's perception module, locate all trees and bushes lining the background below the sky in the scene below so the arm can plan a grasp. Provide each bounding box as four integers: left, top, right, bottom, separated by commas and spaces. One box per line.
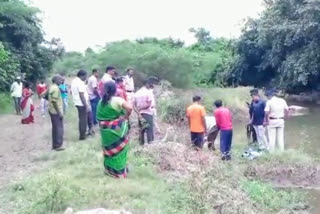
0, 0, 320, 92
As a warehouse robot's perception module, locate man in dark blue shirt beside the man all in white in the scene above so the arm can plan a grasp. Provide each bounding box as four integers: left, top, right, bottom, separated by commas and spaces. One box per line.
250, 90, 269, 150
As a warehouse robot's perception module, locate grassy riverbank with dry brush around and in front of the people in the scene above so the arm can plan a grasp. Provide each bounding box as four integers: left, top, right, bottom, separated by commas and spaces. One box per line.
0, 89, 317, 214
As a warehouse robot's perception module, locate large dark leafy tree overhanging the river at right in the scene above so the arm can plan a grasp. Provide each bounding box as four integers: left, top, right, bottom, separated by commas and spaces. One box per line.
229, 0, 320, 91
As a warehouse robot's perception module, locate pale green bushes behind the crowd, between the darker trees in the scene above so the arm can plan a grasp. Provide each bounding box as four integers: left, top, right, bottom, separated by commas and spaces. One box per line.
55, 35, 232, 88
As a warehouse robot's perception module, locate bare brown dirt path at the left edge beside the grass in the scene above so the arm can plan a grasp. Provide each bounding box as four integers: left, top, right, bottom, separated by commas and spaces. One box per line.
0, 104, 51, 189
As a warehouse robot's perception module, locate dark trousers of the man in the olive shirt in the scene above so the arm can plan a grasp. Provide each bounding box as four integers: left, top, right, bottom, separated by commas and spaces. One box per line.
50, 113, 64, 149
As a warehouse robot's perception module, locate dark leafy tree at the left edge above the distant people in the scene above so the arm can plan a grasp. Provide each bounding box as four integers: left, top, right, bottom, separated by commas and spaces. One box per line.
0, 0, 63, 91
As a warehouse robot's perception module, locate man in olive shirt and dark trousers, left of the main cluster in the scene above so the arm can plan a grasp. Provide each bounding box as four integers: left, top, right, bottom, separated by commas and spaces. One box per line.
48, 75, 64, 151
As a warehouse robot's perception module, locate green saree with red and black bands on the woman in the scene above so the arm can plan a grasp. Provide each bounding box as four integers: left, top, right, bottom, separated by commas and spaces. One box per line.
97, 101, 129, 178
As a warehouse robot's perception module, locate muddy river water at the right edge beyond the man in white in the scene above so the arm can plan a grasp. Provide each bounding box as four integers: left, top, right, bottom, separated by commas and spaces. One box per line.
234, 103, 320, 214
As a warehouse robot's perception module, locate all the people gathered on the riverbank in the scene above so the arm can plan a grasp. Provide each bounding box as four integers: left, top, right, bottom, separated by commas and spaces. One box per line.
11, 66, 289, 178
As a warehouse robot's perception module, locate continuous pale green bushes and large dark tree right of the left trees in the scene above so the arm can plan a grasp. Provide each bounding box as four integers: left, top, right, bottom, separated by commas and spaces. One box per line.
55, 0, 320, 92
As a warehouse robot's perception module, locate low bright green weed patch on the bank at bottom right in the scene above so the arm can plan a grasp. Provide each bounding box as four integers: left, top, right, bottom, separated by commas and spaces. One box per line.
242, 181, 305, 211
